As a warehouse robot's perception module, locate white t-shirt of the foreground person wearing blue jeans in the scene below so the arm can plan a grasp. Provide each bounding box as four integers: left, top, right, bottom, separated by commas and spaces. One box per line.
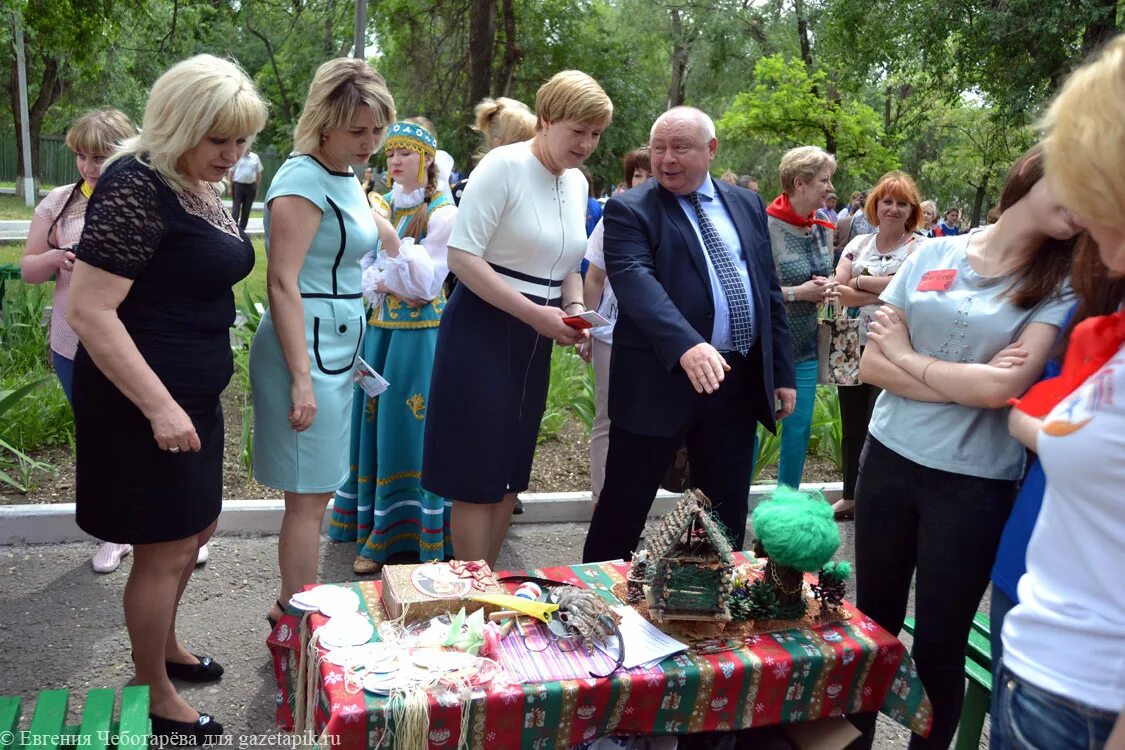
1004, 347, 1125, 712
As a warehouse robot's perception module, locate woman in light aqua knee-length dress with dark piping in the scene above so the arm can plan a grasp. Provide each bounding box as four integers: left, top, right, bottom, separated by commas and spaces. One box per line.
250, 58, 397, 623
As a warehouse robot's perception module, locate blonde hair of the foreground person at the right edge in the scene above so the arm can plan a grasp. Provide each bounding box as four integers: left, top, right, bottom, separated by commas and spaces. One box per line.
1043, 35, 1125, 227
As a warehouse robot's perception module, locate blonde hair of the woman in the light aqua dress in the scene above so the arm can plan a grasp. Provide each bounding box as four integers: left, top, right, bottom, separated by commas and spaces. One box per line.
293, 57, 395, 154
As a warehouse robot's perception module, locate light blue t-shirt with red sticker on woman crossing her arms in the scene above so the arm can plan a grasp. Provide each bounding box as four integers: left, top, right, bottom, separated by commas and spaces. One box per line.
869, 229, 1073, 479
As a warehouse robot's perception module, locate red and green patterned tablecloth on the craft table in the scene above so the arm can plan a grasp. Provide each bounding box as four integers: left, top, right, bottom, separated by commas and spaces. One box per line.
269, 558, 932, 750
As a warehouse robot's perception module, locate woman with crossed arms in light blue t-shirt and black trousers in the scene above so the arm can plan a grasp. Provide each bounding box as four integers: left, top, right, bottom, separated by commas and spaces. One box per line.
855, 146, 1078, 748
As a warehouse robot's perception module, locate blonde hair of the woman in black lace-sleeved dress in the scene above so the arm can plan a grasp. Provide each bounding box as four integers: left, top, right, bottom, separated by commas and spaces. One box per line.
107, 55, 266, 191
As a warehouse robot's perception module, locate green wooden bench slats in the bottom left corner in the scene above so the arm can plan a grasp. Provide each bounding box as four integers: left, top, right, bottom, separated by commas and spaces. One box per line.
0, 685, 152, 750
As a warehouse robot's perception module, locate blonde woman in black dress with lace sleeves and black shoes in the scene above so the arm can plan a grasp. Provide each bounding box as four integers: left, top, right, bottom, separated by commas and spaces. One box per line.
68, 55, 266, 744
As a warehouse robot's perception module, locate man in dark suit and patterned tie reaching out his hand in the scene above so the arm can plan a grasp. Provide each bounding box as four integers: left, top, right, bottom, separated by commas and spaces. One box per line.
583, 107, 797, 562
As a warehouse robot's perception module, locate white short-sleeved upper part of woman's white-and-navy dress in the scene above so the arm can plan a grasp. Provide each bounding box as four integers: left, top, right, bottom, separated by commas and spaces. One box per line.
449, 142, 587, 300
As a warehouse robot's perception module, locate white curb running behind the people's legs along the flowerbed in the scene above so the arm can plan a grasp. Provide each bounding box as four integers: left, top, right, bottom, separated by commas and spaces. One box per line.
0, 482, 843, 545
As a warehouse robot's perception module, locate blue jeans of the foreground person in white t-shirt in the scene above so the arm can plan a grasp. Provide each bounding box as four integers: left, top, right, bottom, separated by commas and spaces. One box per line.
989, 665, 1117, 750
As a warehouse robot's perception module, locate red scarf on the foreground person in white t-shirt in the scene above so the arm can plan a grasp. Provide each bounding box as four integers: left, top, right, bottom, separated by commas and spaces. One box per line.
1008, 310, 1125, 417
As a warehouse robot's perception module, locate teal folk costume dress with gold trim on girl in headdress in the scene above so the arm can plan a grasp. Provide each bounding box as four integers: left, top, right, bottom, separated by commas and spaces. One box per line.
329, 188, 453, 562
